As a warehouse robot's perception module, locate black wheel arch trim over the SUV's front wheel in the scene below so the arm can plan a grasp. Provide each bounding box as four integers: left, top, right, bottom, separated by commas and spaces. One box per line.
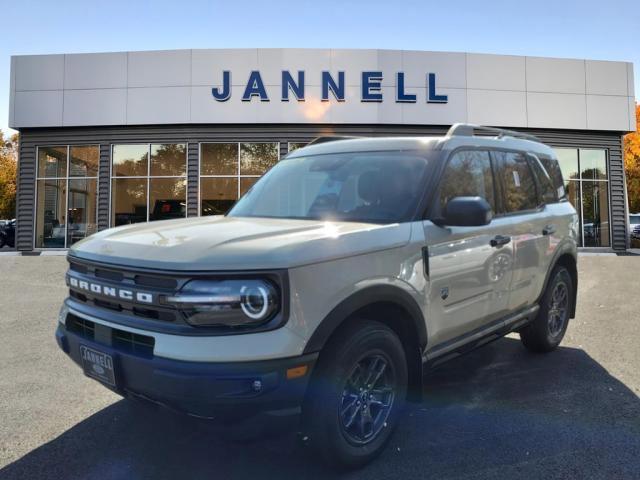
304, 285, 428, 400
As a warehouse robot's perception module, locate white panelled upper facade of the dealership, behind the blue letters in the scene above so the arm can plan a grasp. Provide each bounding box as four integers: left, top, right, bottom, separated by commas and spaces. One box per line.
9, 49, 635, 131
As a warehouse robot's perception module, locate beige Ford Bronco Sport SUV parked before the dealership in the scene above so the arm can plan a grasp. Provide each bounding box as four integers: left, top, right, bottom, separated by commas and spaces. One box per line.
56, 124, 578, 466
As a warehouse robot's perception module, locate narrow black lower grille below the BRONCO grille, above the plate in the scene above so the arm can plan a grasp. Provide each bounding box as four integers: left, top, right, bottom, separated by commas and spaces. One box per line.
65, 313, 155, 357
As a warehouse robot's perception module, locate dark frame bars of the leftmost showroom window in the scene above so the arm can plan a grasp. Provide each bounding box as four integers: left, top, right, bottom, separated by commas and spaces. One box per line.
33, 143, 100, 251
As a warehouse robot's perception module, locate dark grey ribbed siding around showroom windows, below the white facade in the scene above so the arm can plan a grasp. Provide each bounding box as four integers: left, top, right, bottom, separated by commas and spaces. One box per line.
16, 124, 627, 251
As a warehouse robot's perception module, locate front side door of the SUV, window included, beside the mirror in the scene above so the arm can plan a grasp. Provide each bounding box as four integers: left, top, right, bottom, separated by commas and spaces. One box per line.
424, 150, 513, 343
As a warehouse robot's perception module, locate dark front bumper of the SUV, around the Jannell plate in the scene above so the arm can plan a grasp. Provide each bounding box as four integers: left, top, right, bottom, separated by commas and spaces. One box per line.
56, 323, 317, 421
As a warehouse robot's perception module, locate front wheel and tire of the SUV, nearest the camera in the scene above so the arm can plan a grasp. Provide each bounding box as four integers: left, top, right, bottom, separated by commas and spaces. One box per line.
302, 320, 408, 468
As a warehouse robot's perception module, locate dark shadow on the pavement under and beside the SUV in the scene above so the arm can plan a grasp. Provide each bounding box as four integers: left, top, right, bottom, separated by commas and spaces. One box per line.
0, 338, 640, 480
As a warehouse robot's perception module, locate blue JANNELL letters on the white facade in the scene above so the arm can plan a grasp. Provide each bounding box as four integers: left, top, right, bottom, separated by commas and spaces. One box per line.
211, 70, 449, 103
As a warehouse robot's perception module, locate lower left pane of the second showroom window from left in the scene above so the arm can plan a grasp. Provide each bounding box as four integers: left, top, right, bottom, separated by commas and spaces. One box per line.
111, 178, 147, 227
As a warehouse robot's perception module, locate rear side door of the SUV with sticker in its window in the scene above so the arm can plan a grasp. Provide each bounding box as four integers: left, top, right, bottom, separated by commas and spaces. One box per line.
492, 151, 555, 311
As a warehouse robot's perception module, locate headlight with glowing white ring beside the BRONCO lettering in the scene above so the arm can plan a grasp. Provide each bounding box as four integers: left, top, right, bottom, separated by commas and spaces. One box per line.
166, 279, 280, 327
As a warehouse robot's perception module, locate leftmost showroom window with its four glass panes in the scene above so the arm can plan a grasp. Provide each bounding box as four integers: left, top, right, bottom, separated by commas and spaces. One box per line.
36, 145, 100, 248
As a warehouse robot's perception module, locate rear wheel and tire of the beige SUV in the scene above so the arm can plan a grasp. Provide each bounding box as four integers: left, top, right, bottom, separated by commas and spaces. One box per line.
520, 266, 574, 353
